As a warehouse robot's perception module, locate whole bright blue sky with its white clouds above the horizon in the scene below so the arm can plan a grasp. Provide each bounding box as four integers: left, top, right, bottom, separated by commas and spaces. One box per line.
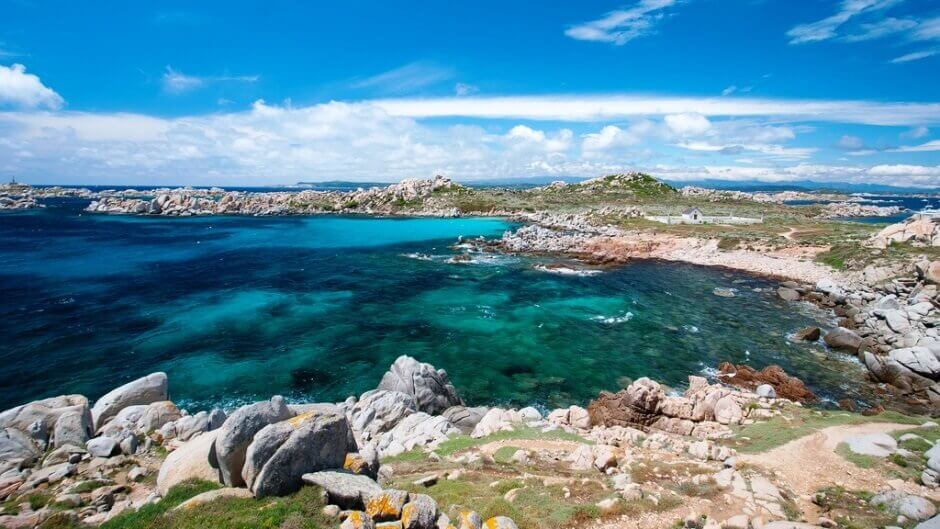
0, 0, 940, 186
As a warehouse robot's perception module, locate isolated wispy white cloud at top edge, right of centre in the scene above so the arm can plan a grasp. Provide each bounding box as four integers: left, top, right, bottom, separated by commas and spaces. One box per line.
565, 0, 676, 46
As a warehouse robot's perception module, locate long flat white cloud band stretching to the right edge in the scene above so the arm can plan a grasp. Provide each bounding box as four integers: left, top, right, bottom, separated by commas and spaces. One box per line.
372, 95, 940, 126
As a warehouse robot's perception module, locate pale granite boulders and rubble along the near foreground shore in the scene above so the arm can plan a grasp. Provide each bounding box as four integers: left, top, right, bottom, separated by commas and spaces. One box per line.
9, 356, 924, 529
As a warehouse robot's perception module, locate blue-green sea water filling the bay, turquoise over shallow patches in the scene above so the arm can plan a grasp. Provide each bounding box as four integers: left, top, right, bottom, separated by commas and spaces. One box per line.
0, 200, 864, 409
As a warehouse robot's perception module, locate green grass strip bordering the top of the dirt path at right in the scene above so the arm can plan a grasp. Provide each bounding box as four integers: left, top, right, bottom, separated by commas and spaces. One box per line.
727, 406, 927, 454
